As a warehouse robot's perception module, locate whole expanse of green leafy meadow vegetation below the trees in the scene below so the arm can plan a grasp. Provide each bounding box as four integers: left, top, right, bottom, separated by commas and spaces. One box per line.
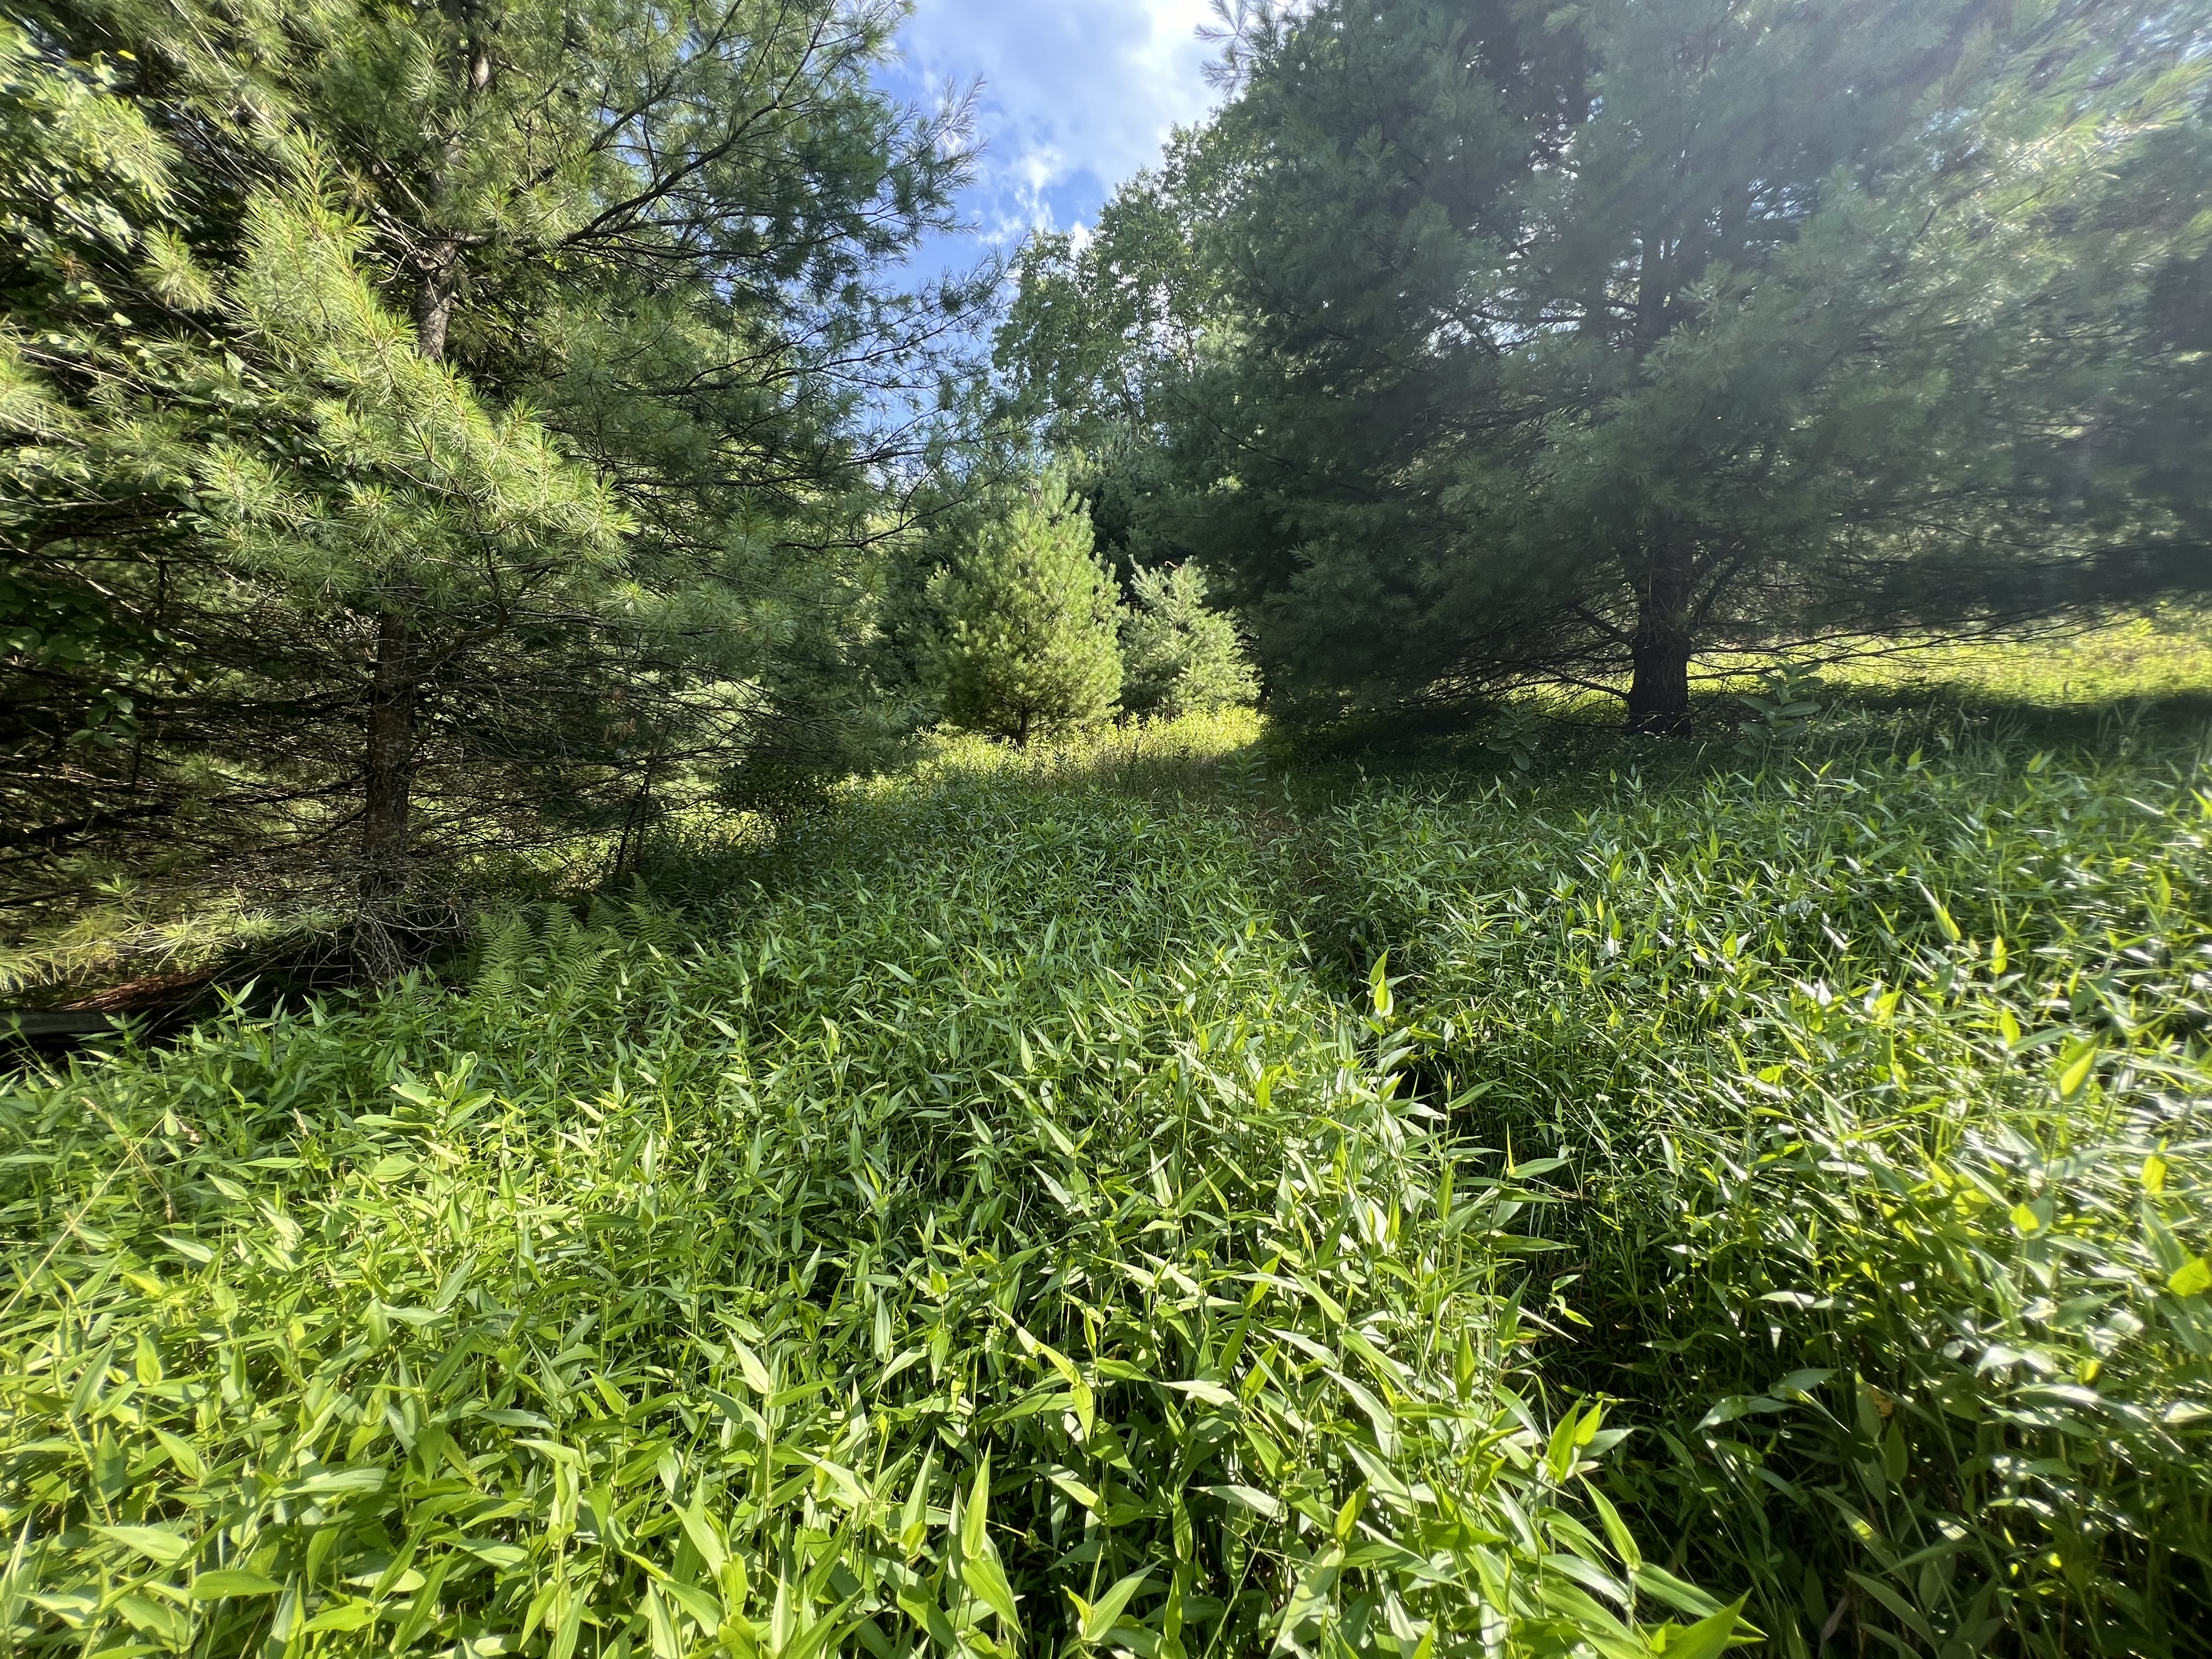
0, 633, 2212, 1659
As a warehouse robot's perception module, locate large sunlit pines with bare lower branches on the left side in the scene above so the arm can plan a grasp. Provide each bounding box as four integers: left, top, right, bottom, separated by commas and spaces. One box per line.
0, 0, 975, 973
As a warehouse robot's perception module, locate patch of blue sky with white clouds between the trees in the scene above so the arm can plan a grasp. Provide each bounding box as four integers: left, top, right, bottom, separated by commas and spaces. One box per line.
881, 0, 1212, 270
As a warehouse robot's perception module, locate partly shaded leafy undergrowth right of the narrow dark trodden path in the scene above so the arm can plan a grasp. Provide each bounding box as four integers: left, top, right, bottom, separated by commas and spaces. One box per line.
1310, 721, 2212, 1655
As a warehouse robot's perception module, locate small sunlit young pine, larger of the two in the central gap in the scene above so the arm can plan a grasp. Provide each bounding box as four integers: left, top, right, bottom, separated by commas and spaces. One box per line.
927, 478, 1121, 743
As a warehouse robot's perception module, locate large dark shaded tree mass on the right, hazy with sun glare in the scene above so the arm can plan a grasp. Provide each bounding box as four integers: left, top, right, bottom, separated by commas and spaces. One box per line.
1000, 0, 2212, 732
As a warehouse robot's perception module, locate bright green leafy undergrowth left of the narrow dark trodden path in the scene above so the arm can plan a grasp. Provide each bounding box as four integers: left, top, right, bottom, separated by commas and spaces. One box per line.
0, 772, 1736, 1659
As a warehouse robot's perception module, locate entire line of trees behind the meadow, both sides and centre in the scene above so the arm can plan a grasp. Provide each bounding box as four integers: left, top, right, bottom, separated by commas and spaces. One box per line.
13, 0, 2212, 975
